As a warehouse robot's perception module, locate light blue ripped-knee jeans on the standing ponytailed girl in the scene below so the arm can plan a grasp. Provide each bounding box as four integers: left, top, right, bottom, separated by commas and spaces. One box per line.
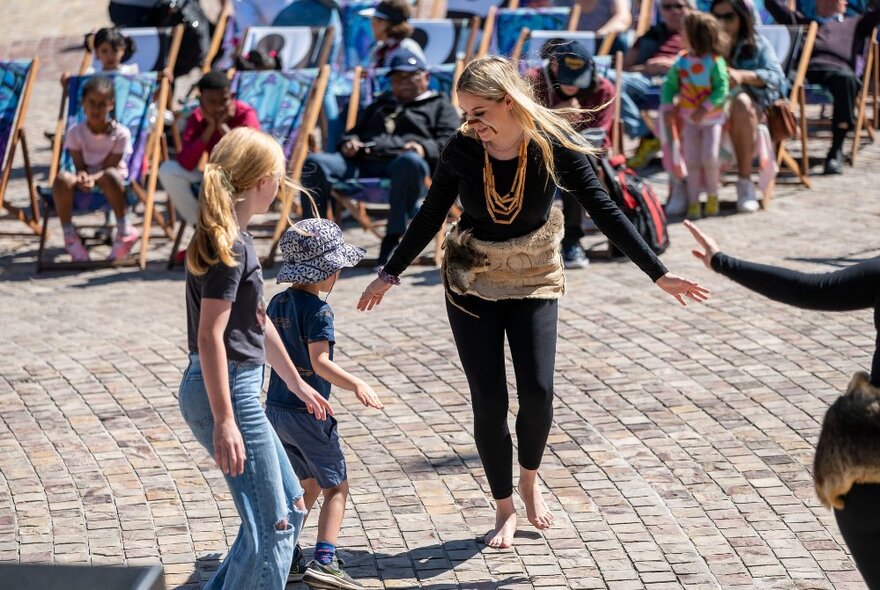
178, 354, 305, 590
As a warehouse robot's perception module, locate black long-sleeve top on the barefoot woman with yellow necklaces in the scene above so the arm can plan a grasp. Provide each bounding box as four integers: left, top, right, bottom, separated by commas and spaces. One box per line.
385, 131, 667, 281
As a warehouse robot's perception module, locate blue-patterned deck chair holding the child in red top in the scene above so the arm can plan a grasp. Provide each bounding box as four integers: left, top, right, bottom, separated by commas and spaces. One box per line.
168, 64, 330, 269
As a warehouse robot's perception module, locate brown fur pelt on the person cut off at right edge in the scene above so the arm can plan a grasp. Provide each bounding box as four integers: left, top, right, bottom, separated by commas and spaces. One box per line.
813, 371, 880, 510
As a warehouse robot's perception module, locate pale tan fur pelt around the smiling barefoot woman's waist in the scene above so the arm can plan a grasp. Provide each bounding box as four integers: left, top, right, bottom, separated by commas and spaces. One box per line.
441, 207, 565, 301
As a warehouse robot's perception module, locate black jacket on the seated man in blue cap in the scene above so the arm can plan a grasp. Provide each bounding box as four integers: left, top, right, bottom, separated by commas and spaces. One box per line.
342, 92, 461, 170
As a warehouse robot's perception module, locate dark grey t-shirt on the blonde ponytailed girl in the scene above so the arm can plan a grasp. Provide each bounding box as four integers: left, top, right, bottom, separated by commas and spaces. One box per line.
186, 232, 266, 365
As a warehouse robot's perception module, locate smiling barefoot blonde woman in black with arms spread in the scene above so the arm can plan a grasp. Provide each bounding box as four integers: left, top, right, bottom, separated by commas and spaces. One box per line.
358, 57, 708, 548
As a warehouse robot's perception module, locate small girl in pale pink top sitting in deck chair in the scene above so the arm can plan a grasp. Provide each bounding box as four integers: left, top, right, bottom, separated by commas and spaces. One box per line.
52, 76, 139, 262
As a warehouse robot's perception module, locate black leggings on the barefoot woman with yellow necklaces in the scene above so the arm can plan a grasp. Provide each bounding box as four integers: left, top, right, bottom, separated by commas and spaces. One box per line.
446, 295, 558, 500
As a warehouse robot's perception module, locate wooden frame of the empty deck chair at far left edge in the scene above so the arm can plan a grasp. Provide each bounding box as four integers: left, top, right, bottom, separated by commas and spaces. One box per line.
0, 56, 40, 235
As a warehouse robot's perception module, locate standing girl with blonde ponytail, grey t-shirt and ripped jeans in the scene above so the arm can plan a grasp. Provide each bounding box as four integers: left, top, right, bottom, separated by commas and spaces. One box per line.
179, 127, 332, 590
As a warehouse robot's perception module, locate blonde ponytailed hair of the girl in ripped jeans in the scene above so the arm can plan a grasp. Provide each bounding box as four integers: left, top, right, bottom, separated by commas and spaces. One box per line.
186, 127, 288, 276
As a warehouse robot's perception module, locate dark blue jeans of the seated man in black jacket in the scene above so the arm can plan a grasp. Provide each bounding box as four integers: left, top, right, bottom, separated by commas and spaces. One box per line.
303, 152, 431, 235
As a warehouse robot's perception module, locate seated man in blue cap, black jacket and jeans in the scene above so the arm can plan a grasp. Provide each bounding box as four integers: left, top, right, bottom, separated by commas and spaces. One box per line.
303, 49, 461, 264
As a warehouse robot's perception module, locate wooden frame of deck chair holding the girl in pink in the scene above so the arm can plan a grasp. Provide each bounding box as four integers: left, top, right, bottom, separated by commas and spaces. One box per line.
37, 73, 171, 272
